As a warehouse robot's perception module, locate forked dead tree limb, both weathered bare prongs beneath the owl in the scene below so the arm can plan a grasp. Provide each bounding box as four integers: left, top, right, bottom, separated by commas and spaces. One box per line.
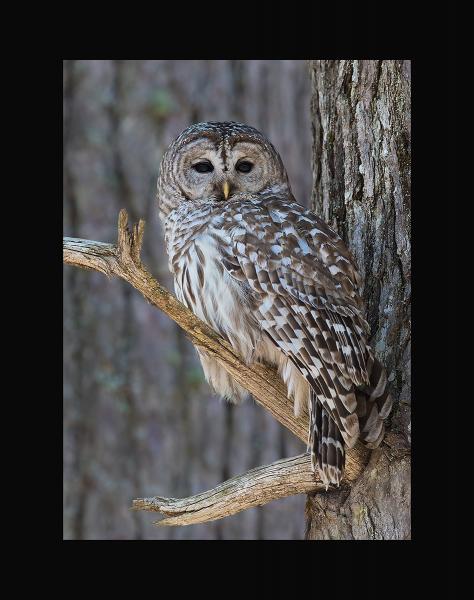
63, 209, 369, 525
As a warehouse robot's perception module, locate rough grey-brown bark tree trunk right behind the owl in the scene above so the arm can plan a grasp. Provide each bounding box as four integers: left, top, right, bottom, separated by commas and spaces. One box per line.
306, 60, 410, 540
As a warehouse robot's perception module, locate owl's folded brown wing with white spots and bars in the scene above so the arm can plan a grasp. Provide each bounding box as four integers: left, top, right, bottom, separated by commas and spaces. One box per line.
223, 196, 372, 447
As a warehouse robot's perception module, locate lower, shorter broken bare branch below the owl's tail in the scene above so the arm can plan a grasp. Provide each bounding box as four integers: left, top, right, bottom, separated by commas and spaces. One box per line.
133, 454, 325, 526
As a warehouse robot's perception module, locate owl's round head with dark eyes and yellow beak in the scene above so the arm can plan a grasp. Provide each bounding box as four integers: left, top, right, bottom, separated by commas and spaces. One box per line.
157, 121, 291, 219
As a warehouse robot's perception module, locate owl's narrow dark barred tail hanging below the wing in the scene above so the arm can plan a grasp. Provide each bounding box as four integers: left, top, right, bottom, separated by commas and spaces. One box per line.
308, 390, 345, 490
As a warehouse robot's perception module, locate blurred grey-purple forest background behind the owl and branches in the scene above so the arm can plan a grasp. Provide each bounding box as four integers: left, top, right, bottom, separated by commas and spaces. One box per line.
63, 60, 312, 539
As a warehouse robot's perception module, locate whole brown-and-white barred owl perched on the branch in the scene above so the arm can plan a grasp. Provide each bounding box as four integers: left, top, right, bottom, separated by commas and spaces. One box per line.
158, 122, 391, 489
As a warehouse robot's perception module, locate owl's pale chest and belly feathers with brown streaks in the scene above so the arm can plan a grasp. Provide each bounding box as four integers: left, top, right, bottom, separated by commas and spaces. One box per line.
165, 207, 309, 414
